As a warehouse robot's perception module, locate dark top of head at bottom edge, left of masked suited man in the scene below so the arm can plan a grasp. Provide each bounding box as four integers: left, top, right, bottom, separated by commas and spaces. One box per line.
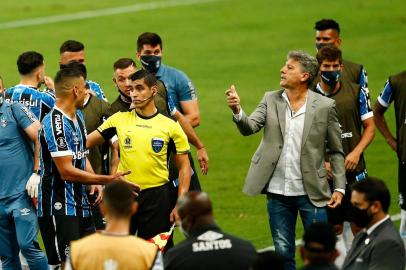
303, 222, 337, 253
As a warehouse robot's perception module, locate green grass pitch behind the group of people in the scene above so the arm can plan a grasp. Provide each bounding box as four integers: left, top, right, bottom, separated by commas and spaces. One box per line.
0, 0, 406, 266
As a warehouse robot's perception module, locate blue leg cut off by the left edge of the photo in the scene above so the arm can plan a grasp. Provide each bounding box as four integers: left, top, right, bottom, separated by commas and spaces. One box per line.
0, 198, 21, 270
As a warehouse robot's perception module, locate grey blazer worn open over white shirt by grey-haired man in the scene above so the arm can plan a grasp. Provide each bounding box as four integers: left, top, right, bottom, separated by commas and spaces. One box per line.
234, 90, 346, 207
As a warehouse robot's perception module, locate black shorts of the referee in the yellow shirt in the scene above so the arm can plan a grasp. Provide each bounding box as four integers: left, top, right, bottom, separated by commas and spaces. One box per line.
130, 182, 174, 247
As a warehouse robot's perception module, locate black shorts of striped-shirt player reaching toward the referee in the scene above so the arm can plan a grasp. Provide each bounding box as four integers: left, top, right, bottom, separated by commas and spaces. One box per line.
38, 215, 95, 265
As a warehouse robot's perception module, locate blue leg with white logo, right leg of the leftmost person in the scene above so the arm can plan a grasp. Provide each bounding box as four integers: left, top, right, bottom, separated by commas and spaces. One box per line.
13, 193, 48, 270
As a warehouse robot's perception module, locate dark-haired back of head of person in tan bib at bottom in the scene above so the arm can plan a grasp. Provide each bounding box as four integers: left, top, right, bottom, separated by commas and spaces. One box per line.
103, 181, 136, 218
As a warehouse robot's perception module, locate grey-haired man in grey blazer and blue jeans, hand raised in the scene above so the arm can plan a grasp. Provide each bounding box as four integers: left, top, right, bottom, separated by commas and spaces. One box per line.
226, 51, 345, 270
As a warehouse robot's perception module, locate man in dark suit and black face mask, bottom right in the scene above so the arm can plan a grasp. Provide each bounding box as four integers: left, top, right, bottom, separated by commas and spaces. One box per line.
342, 177, 405, 270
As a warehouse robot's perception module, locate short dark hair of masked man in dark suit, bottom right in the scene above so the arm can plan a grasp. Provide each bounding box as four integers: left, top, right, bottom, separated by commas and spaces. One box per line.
351, 176, 390, 213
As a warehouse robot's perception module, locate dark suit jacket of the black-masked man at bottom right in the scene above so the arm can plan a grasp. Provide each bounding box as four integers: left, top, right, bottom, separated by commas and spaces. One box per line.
342, 219, 405, 270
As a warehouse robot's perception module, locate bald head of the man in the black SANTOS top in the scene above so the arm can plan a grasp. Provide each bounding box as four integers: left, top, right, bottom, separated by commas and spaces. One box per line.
177, 191, 214, 232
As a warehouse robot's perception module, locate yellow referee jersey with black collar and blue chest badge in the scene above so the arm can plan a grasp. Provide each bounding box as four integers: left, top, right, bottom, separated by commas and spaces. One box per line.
97, 110, 189, 189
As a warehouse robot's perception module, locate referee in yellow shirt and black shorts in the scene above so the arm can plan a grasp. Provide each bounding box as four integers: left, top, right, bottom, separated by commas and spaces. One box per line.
87, 70, 191, 247
